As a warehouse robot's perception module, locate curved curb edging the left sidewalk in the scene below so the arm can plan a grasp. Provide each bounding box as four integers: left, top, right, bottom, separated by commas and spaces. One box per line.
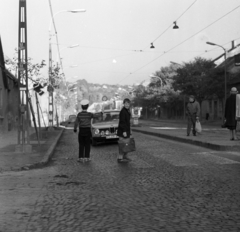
18, 129, 64, 171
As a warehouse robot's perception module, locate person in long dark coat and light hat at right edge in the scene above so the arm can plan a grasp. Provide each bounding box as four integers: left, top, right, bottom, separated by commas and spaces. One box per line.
225, 87, 238, 140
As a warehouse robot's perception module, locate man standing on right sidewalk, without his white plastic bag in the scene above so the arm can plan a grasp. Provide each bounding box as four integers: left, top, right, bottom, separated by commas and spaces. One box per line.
186, 95, 200, 136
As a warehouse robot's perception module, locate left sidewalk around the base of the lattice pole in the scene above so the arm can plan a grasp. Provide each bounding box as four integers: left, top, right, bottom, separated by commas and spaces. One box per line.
0, 128, 64, 172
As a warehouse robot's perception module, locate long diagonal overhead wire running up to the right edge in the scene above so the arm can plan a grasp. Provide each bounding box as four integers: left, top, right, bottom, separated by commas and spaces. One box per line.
119, 5, 240, 83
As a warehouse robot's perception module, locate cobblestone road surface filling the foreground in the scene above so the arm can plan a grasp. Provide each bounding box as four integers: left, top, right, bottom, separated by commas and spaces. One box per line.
0, 130, 240, 232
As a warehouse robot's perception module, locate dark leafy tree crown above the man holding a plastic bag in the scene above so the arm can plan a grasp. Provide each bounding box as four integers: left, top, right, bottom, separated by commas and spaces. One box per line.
173, 57, 215, 103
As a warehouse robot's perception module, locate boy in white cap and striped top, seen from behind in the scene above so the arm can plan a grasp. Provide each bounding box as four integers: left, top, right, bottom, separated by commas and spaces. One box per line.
73, 99, 93, 162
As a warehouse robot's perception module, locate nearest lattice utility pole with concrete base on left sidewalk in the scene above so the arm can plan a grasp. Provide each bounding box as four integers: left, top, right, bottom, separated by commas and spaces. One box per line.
16, 0, 32, 152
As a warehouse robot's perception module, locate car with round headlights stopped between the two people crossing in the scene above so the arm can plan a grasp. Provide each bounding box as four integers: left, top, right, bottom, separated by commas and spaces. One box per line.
91, 110, 120, 146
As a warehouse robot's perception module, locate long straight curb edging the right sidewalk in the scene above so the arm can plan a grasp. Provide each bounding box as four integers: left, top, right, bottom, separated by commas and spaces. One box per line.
132, 128, 240, 151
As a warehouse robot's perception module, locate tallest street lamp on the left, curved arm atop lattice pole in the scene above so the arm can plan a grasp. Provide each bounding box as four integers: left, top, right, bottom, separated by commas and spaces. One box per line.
48, 9, 86, 130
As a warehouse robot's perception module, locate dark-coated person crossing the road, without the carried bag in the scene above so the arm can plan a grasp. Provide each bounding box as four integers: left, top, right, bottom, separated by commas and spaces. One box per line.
117, 98, 131, 162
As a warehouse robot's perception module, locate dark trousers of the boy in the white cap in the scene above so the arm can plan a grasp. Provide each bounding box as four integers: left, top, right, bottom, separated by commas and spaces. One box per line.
78, 127, 92, 158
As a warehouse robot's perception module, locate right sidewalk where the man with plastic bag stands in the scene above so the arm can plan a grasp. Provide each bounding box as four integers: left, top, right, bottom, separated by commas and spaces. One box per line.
132, 120, 240, 151
